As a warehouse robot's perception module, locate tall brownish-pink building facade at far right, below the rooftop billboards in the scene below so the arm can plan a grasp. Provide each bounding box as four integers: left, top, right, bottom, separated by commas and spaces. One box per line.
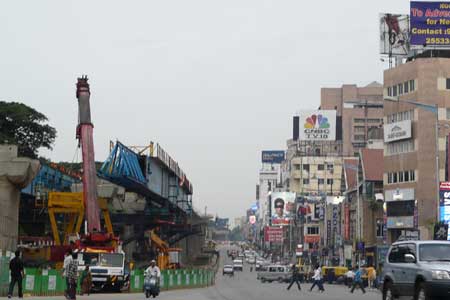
383, 58, 450, 242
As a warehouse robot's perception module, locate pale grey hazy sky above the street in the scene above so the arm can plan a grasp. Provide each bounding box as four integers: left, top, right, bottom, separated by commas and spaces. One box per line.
0, 0, 409, 217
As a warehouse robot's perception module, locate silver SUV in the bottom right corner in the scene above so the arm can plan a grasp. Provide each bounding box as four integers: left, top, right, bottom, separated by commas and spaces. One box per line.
381, 240, 450, 300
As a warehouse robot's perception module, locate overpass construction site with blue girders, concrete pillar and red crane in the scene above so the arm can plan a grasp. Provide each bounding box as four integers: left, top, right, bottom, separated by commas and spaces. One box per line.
0, 76, 218, 291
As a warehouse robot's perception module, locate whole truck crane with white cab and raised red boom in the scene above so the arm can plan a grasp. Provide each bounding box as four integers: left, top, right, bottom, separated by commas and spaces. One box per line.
76, 76, 126, 291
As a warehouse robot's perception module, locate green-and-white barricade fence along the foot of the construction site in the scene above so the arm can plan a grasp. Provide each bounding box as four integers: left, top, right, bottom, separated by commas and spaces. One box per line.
0, 256, 215, 297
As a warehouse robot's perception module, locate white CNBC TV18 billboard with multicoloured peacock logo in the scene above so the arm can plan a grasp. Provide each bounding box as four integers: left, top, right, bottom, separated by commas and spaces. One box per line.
298, 110, 336, 141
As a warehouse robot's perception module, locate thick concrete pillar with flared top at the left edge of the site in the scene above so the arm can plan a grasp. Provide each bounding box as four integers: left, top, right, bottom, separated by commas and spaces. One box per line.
0, 145, 40, 251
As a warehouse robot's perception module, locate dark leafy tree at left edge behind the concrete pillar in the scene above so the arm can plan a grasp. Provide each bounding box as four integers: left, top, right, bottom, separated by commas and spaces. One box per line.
0, 101, 56, 158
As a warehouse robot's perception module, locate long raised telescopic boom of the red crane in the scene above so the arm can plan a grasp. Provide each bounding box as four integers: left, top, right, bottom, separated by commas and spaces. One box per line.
77, 76, 101, 233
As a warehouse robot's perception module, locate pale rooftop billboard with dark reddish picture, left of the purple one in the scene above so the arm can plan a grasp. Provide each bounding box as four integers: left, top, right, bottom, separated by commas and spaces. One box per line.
379, 13, 409, 56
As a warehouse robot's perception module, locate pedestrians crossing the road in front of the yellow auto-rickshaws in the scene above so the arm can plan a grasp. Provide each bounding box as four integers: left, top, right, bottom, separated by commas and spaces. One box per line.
287, 264, 377, 294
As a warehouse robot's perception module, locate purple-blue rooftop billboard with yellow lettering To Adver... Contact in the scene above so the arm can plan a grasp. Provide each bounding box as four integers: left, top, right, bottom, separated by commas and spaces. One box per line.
410, 1, 450, 48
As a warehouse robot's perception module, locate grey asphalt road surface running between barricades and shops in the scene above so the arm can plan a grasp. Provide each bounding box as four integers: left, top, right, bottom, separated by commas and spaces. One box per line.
24, 247, 381, 300
